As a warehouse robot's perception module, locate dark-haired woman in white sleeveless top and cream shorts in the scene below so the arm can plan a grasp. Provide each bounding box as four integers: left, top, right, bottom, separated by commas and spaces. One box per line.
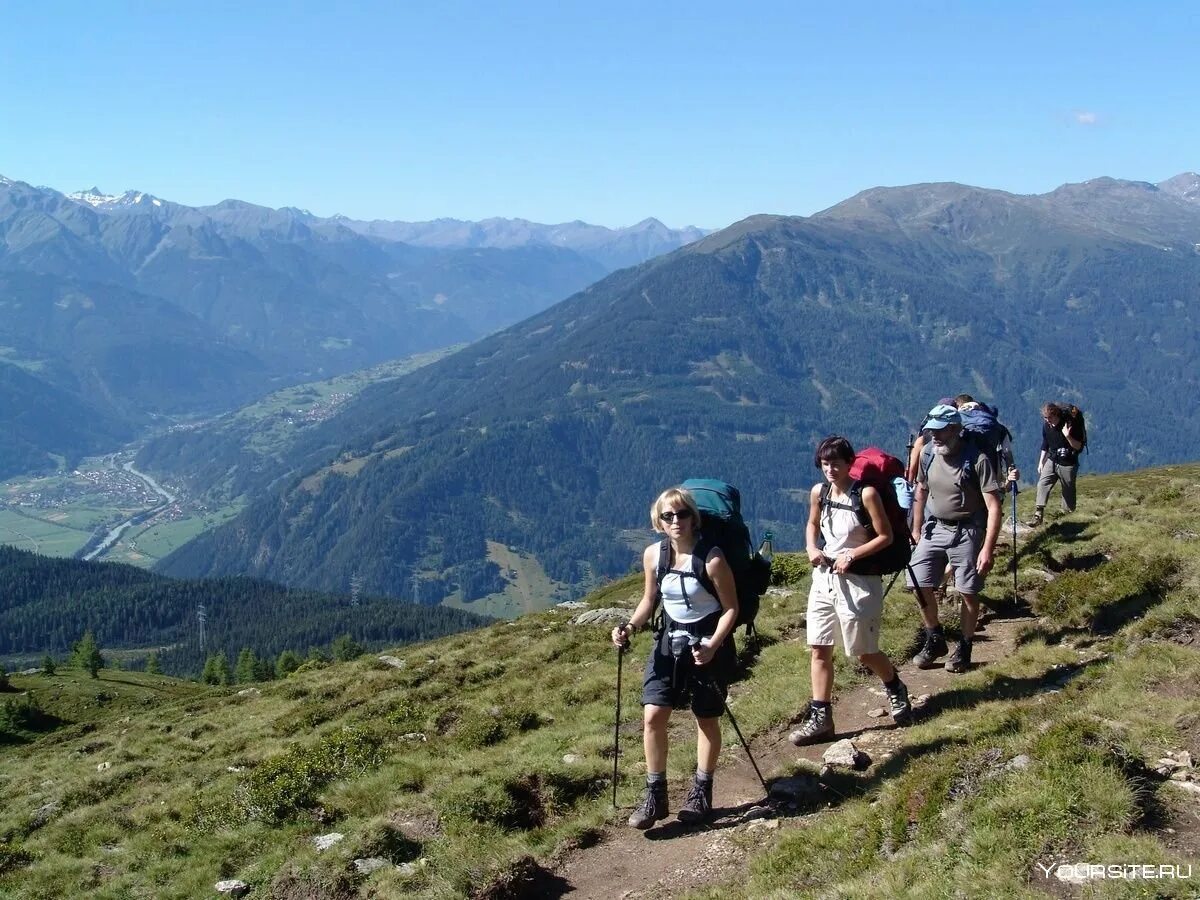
788, 434, 912, 746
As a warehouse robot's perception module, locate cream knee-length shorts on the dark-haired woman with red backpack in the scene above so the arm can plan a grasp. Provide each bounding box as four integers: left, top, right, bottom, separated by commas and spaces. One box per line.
808, 565, 883, 656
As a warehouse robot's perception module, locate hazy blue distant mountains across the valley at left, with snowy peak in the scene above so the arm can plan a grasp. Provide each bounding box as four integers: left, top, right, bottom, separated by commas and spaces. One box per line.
0, 178, 700, 476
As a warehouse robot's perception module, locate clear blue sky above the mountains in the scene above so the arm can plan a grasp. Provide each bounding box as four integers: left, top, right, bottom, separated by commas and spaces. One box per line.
0, 0, 1200, 227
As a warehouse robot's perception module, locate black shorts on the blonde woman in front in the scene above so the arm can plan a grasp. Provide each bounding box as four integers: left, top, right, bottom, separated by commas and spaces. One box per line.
642, 613, 737, 719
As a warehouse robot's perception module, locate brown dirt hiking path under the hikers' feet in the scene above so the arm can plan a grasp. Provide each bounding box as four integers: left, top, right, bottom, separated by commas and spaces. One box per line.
535, 617, 1021, 900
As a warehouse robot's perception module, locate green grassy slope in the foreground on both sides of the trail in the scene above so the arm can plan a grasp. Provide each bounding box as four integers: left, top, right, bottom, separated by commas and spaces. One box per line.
0, 466, 1200, 899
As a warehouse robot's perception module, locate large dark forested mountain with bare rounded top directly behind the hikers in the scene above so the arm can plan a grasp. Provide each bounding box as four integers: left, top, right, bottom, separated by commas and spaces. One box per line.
154, 174, 1200, 614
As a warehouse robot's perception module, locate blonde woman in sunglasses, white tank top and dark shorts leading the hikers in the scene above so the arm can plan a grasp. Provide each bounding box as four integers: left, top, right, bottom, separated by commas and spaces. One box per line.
612, 487, 738, 829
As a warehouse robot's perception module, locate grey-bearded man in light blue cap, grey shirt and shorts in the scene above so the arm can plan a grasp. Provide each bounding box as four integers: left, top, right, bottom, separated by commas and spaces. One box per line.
910, 403, 1003, 672
